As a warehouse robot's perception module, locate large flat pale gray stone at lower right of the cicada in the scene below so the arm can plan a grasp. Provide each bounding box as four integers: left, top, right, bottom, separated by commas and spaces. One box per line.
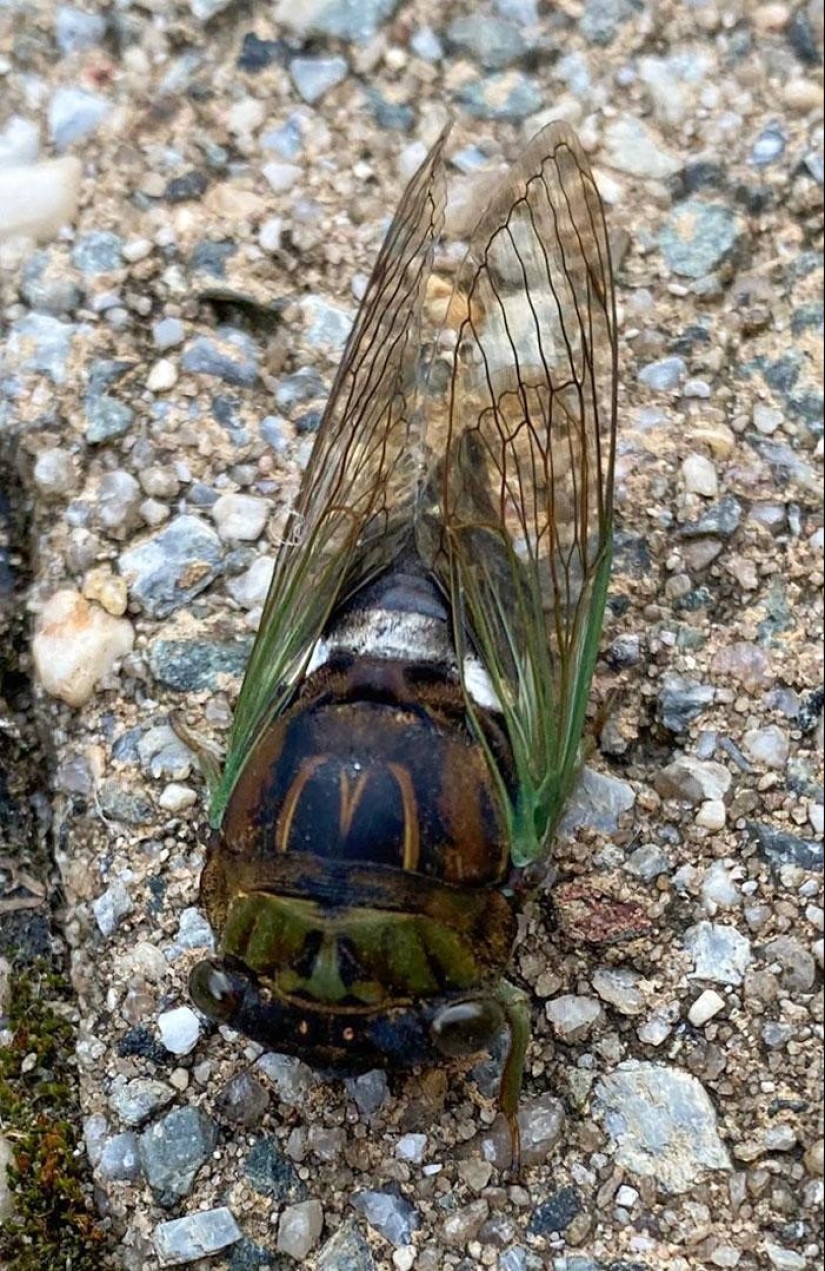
594, 1060, 731, 1193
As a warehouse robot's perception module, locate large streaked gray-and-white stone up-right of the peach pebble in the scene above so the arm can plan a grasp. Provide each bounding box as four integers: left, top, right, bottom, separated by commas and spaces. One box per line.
119, 515, 224, 618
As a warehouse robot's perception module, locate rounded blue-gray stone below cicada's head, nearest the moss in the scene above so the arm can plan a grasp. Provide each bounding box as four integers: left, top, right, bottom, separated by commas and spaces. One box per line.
139, 1107, 217, 1205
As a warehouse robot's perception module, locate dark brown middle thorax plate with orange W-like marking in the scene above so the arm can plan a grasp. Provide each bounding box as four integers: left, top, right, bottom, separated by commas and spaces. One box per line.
222, 658, 508, 886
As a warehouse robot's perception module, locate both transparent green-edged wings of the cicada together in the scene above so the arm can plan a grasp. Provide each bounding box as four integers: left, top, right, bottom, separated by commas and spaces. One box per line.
211, 123, 617, 866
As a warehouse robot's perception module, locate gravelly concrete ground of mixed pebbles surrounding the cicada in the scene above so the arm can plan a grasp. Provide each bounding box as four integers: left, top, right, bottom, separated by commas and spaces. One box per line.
0, 0, 824, 1271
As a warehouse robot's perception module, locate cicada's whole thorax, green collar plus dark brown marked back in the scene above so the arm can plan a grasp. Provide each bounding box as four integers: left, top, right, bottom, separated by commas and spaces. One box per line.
202, 582, 515, 1012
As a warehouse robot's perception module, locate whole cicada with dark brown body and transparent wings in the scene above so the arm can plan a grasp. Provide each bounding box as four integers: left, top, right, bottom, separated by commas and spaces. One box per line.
185, 123, 617, 1154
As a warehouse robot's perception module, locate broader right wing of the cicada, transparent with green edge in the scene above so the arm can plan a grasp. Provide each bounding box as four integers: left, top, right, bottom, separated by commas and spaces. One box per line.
418, 125, 617, 864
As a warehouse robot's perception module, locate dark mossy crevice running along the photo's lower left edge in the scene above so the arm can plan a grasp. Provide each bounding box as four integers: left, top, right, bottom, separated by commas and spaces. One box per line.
0, 441, 104, 1271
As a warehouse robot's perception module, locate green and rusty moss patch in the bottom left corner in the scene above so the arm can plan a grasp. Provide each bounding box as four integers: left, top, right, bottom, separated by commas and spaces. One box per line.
0, 961, 104, 1271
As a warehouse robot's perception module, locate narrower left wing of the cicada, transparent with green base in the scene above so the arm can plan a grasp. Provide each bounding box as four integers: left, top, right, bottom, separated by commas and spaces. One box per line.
210, 130, 447, 825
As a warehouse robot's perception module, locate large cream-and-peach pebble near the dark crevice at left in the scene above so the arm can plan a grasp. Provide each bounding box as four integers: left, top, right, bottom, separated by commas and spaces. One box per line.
32, 587, 135, 707
